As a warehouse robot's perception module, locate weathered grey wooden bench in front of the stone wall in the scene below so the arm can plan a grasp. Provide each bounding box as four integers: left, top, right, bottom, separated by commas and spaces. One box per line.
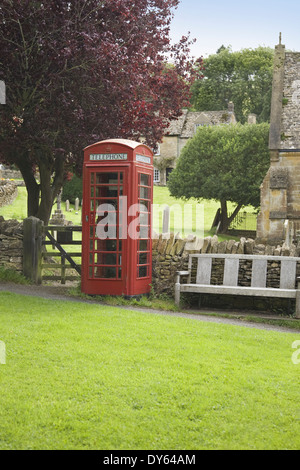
175, 253, 300, 318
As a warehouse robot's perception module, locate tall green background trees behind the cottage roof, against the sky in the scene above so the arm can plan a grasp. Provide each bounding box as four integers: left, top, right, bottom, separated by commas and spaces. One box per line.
191, 46, 274, 123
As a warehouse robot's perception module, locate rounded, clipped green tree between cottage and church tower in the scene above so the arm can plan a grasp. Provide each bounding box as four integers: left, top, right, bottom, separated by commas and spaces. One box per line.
168, 123, 269, 233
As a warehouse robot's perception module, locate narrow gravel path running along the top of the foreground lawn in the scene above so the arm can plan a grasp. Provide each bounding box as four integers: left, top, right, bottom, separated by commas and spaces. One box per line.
0, 283, 299, 334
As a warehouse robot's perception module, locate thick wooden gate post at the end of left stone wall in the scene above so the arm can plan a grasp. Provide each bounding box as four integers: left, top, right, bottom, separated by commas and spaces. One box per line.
23, 217, 44, 284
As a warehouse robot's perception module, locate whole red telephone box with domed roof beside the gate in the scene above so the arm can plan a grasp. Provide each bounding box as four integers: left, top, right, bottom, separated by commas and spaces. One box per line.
81, 139, 153, 296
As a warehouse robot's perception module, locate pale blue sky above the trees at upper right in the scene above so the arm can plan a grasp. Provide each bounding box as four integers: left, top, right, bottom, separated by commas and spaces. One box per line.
170, 0, 300, 57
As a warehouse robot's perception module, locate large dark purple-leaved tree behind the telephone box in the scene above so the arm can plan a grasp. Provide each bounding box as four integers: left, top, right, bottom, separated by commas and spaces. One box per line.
0, 0, 202, 223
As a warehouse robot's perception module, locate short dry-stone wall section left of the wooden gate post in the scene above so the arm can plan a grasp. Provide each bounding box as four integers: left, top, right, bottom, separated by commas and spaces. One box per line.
0, 216, 23, 273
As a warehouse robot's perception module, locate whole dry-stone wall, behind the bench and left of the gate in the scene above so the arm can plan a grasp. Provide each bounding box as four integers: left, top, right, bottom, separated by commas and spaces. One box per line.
0, 216, 300, 313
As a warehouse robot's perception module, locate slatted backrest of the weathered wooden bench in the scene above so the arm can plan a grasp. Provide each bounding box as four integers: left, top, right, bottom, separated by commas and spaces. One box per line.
189, 253, 300, 289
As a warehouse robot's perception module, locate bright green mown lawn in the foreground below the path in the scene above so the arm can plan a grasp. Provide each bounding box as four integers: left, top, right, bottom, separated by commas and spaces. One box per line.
0, 292, 300, 450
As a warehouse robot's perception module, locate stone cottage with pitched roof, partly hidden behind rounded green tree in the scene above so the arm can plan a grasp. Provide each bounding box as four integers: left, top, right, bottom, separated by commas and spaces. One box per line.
154, 102, 236, 185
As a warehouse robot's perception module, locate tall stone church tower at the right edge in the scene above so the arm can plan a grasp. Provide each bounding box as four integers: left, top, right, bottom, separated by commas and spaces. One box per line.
257, 35, 300, 242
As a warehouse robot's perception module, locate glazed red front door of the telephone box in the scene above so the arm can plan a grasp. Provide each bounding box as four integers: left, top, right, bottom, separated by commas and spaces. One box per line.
83, 167, 128, 295
